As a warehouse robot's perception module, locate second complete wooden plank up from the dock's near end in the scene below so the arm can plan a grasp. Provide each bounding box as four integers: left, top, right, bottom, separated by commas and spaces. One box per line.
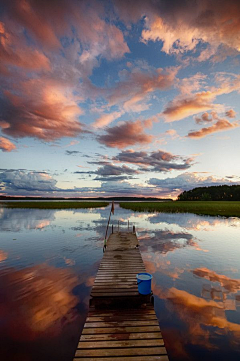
78, 339, 163, 349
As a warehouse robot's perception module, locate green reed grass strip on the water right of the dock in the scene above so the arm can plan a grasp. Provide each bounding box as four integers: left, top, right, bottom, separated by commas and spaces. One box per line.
120, 201, 240, 217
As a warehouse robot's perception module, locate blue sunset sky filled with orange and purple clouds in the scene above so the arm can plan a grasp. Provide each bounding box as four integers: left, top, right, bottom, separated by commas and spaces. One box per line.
0, 0, 240, 199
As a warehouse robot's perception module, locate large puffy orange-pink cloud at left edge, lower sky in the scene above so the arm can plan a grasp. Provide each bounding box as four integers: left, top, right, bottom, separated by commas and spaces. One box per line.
0, 83, 83, 141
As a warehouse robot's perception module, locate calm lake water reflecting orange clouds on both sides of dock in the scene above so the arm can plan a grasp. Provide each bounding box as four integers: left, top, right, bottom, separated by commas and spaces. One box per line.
0, 205, 240, 361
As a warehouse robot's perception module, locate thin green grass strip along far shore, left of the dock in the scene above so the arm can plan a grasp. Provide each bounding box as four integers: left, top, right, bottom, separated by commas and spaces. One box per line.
0, 201, 109, 209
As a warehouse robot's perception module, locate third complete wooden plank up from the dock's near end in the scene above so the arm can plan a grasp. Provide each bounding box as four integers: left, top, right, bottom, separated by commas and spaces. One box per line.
81, 332, 162, 341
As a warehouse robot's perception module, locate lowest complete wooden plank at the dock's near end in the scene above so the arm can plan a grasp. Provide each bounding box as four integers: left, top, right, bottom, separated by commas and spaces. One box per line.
75, 346, 167, 357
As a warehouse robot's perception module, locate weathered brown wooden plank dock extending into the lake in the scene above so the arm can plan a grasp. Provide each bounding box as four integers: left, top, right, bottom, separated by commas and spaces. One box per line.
74, 232, 168, 361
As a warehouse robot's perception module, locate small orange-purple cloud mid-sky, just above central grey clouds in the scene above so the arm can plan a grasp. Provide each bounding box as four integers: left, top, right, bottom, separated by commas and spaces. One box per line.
97, 120, 153, 149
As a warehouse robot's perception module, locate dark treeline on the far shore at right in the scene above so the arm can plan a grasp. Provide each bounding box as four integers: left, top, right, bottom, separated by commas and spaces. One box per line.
178, 185, 240, 201
